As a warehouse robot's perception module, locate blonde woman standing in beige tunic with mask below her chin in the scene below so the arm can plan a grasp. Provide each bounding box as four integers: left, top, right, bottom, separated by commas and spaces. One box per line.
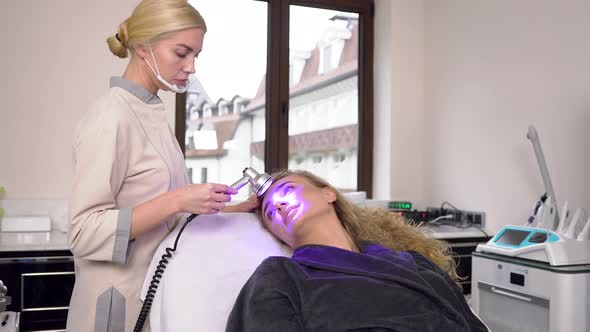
67, 0, 256, 332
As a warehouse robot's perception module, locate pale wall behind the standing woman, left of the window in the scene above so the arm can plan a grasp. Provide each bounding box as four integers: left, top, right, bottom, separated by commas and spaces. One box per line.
0, 0, 174, 199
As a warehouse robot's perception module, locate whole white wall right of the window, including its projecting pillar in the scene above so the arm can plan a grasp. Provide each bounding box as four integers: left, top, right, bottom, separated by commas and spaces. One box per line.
374, 0, 590, 231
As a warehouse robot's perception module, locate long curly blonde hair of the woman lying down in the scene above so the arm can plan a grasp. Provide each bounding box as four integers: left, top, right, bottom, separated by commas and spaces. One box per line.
258, 170, 460, 283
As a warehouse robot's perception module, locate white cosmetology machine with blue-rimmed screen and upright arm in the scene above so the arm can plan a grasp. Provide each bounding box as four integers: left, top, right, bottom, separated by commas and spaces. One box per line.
471, 126, 590, 332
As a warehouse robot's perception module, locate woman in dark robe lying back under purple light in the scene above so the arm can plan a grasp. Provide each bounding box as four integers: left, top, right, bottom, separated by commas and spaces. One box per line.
226, 171, 487, 332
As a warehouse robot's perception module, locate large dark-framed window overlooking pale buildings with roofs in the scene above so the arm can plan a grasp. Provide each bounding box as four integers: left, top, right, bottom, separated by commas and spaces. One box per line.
176, 0, 373, 197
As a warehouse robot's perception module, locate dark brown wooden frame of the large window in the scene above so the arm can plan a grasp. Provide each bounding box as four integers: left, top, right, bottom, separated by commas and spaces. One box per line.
175, 0, 375, 198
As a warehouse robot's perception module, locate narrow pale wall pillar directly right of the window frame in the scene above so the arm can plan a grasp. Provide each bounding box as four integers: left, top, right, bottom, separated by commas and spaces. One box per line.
373, 0, 426, 202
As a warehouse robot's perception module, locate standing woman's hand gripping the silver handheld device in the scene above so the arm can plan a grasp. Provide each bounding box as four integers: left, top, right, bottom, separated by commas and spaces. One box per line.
174, 183, 238, 214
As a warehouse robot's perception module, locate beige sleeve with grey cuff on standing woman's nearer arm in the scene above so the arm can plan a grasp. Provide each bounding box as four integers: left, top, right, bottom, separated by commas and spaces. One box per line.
68, 107, 133, 264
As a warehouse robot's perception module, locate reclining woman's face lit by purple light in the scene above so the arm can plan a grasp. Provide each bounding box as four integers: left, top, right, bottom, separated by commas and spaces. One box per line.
262, 175, 335, 247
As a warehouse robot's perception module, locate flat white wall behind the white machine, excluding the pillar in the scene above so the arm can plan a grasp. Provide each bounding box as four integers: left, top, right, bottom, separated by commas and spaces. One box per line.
424, 0, 590, 230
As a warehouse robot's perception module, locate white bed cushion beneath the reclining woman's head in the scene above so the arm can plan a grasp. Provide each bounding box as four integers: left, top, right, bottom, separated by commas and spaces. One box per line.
142, 213, 292, 332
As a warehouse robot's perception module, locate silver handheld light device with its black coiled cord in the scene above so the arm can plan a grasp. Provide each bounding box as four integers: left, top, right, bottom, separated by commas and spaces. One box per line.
133, 167, 273, 332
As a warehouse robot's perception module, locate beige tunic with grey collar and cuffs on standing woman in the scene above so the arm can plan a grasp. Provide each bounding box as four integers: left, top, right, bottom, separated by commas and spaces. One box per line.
67, 78, 187, 332
